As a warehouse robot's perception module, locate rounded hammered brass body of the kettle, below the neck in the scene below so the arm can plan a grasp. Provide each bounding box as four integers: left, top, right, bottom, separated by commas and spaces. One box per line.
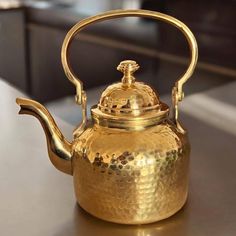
73, 121, 190, 224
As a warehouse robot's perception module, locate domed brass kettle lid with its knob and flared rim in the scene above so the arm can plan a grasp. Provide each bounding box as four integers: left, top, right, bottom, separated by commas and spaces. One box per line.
91, 60, 169, 129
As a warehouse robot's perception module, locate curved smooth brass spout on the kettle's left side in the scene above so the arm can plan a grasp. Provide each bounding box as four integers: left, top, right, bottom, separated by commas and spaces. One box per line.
16, 98, 72, 175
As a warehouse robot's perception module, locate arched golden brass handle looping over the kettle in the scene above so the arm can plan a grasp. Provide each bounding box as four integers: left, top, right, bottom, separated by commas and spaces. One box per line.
61, 10, 198, 125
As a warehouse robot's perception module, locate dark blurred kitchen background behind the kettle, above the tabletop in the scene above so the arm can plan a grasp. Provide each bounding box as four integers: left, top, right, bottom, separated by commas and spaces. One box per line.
0, 0, 236, 123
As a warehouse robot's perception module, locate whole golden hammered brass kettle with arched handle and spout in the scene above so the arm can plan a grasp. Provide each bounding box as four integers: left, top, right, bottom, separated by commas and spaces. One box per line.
16, 10, 198, 224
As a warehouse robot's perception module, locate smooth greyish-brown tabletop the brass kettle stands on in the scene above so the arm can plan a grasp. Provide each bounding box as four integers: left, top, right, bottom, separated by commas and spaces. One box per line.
0, 81, 236, 236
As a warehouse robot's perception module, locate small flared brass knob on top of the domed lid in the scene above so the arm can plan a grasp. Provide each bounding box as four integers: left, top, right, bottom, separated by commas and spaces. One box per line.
117, 60, 139, 87
